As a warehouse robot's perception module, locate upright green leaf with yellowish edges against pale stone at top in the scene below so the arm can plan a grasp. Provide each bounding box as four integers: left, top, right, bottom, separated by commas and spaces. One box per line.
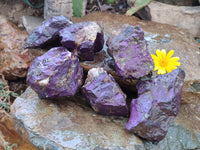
72, 0, 83, 17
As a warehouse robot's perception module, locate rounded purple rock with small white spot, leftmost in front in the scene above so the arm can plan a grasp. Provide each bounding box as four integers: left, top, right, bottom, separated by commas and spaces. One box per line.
27, 47, 83, 98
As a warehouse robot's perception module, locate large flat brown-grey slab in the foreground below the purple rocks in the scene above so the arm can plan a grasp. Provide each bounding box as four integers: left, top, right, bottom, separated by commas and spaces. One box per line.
11, 82, 200, 150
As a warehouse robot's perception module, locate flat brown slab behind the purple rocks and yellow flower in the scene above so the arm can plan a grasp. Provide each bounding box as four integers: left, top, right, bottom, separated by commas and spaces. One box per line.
72, 12, 200, 103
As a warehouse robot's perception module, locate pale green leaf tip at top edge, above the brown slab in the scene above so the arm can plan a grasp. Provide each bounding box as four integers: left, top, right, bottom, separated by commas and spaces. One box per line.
126, 0, 151, 16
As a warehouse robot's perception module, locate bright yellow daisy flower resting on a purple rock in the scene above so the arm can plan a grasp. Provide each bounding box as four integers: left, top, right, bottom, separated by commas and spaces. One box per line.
151, 49, 181, 74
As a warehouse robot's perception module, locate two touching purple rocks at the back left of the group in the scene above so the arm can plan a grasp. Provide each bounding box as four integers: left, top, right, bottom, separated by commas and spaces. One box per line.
23, 16, 104, 61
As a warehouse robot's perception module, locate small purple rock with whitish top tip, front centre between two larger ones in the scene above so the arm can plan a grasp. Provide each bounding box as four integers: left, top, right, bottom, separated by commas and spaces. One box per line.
82, 68, 128, 116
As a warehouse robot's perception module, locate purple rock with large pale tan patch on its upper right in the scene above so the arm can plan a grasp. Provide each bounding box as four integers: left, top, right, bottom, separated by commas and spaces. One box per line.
59, 22, 104, 61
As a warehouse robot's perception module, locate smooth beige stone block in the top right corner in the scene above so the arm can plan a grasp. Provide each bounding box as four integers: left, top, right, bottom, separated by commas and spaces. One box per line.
148, 1, 200, 37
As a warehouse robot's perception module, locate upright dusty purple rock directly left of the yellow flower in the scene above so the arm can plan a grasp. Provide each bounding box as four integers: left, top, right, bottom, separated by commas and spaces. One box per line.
107, 24, 153, 79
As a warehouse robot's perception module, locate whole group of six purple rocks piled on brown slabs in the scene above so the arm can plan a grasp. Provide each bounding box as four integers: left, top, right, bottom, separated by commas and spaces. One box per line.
24, 16, 185, 141
